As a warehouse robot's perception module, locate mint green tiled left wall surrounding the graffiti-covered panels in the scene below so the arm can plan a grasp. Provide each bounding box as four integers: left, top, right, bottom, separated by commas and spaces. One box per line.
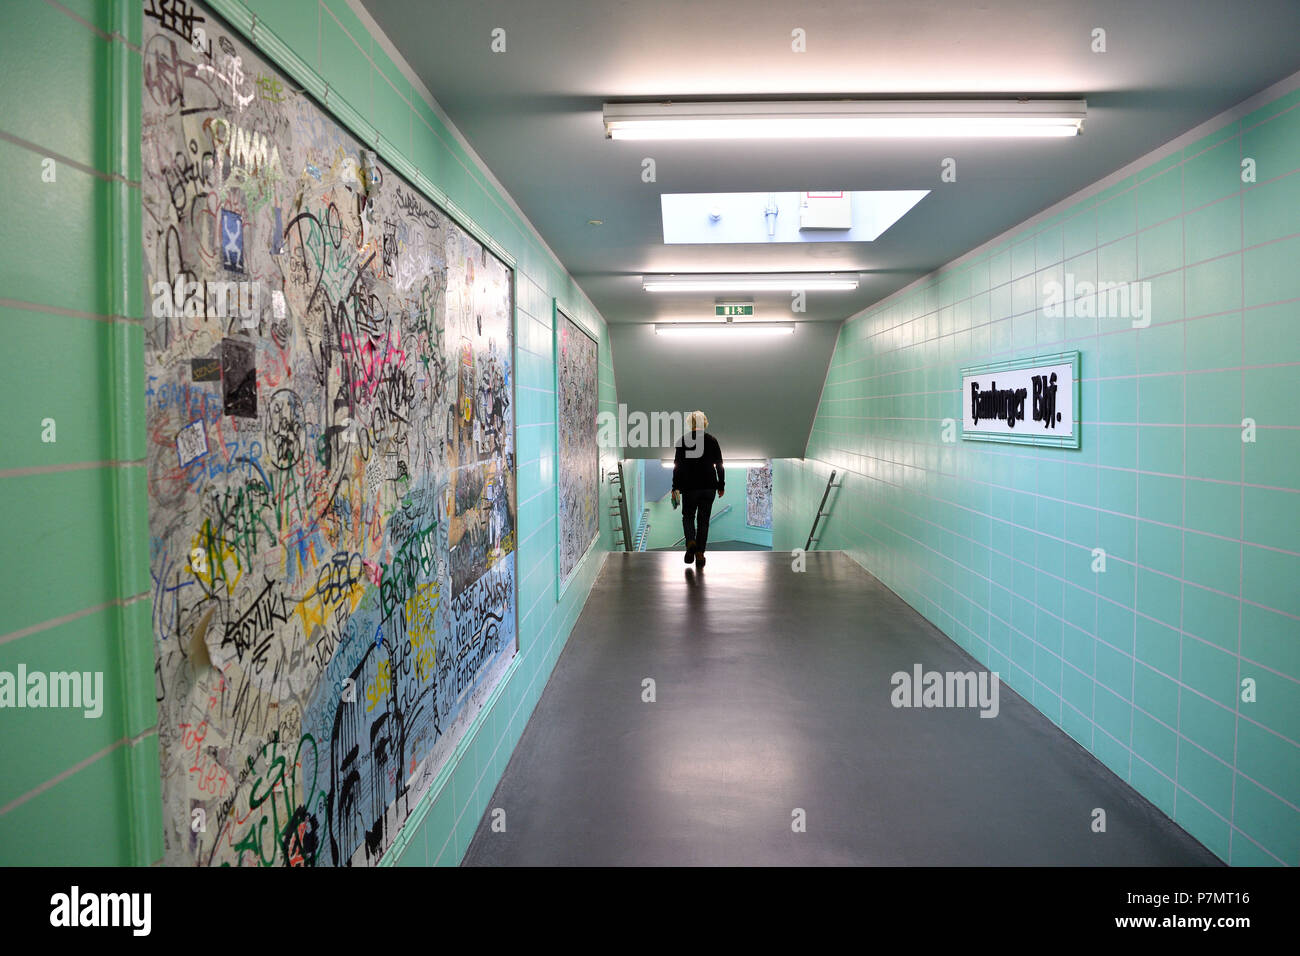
0, 0, 616, 865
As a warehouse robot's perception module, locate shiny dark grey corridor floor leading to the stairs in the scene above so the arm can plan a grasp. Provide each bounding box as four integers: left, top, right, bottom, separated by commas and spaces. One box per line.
464, 551, 1218, 865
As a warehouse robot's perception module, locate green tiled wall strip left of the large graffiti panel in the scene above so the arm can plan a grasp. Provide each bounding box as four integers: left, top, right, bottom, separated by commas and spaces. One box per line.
0, 0, 163, 865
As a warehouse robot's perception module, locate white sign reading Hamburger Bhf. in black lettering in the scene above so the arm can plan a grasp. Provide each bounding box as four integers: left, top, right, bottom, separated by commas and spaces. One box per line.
961, 351, 1079, 449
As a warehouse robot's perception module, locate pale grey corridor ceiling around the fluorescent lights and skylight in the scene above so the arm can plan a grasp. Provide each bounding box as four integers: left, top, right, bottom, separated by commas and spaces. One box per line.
361, 0, 1300, 457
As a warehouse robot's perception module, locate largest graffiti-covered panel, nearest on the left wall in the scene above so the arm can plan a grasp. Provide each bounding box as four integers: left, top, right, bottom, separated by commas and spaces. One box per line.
142, 0, 517, 866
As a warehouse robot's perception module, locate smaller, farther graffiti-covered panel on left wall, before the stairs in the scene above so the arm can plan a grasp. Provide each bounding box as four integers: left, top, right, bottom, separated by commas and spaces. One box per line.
555, 308, 601, 589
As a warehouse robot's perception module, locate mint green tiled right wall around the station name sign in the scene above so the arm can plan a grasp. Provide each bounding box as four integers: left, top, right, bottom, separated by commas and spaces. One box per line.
774, 94, 1300, 865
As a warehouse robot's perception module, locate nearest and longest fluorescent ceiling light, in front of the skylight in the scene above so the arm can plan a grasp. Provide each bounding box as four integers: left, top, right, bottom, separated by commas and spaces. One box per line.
605, 99, 1088, 139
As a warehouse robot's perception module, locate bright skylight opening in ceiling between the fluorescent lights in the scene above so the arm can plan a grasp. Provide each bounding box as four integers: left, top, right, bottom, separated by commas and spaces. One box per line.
660, 189, 930, 245
